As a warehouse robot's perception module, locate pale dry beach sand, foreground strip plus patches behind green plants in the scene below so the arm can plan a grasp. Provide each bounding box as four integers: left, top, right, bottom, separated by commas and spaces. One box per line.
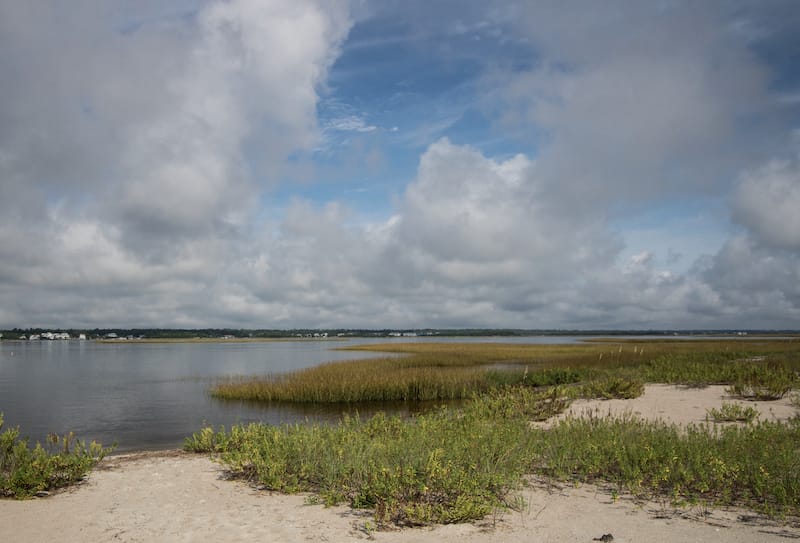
0, 386, 800, 543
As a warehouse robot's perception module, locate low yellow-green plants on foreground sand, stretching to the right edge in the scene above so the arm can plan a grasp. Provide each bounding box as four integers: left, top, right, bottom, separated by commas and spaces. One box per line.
186, 387, 800, 526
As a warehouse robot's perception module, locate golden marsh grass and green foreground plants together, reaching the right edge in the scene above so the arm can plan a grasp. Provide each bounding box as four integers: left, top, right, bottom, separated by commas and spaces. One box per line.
186, 339, 800, 526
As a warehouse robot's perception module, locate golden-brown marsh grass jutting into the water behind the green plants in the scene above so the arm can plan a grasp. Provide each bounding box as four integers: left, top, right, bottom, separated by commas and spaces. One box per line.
212, 339, 800, 403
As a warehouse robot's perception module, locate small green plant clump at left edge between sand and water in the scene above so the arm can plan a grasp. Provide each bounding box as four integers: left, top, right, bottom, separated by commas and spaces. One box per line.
0, 414, 111, 498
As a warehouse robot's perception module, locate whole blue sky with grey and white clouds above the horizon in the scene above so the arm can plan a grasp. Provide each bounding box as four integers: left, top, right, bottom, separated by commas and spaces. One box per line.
0, 0, 800, 329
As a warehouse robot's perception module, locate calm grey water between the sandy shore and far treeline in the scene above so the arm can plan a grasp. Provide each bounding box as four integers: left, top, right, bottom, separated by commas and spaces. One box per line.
0, 337, 576, 451
